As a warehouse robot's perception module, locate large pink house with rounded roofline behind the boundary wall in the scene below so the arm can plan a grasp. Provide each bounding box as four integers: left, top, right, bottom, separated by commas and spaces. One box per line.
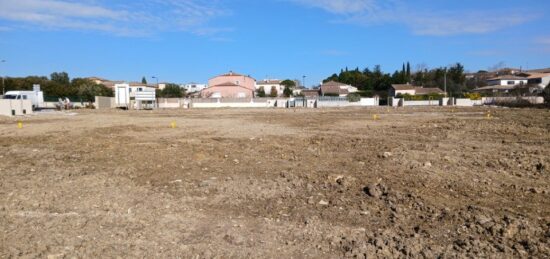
201, 71, 256, 98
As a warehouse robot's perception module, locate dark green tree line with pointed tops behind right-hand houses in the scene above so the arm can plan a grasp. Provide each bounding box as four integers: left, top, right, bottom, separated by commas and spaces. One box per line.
323, 62, 474, 95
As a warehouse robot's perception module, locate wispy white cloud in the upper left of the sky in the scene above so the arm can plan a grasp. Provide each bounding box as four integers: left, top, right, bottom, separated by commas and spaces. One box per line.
0, 0, 231, 36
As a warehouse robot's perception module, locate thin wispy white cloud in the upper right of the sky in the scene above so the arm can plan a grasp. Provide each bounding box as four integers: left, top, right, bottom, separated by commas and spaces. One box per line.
288, 0, 536, 36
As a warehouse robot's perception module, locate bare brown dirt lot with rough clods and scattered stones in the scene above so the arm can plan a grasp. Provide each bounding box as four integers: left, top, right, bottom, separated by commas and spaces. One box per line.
0, 108, 550, 258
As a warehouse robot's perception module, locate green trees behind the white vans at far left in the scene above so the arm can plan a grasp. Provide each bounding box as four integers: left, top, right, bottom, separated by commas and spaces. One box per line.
4, 72, 113, 102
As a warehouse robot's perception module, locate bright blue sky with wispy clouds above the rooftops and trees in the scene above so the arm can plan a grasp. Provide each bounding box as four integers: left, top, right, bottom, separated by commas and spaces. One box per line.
0, 0, 550, 85
